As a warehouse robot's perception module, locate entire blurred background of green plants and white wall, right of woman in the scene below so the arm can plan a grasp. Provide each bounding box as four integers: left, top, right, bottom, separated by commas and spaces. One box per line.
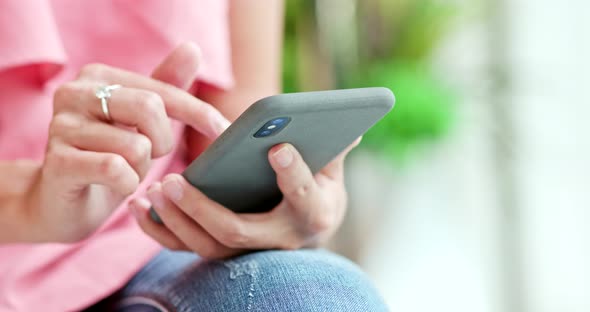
284, 0, 590, 312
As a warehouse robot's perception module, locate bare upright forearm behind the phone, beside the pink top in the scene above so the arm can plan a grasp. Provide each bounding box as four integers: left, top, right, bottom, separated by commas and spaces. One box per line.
188, 0, 284, 159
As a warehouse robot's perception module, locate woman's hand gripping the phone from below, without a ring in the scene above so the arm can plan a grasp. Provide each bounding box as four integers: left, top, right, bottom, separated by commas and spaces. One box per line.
130, 139, 360, 258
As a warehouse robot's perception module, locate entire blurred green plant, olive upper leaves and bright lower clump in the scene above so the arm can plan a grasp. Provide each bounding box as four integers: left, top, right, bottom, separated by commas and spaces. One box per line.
283, 0, 457, 161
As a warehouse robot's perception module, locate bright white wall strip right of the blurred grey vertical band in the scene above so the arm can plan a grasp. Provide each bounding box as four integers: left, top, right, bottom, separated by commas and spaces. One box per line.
507, 0, 590, 312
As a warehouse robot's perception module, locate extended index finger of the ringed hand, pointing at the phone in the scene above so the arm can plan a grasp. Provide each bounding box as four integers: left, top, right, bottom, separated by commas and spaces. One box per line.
80, 64, 230, 139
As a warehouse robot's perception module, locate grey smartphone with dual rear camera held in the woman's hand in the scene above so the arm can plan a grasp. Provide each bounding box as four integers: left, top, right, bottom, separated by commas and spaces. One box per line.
151, 88, 395, 223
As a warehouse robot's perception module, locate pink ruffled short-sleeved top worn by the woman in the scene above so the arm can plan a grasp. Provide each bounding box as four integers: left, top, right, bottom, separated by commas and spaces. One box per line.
0, 0, 232, 311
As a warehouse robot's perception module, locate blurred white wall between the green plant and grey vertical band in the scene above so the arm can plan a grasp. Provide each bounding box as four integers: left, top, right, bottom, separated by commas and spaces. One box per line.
349, 6, 504, 312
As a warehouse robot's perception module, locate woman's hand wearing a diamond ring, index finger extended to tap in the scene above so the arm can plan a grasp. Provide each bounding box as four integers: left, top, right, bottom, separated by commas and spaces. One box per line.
21, 44, 229, 242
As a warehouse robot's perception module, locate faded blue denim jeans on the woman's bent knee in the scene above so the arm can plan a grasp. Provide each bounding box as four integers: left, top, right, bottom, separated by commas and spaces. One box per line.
88, 250, 387, 312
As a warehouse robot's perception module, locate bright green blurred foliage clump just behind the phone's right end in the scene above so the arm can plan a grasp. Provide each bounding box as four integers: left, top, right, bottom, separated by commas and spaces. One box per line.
351, 60, 456, 161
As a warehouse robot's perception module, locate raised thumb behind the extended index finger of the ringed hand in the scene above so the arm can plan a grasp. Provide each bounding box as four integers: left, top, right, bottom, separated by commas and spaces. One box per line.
152, 42, 201, 90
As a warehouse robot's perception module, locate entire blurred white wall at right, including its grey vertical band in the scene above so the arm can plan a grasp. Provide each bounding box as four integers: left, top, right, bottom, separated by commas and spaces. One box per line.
349, 0, 590, 312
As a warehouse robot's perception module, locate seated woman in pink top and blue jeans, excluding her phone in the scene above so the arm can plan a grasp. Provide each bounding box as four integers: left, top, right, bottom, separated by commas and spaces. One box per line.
0, 0, 385, 311
